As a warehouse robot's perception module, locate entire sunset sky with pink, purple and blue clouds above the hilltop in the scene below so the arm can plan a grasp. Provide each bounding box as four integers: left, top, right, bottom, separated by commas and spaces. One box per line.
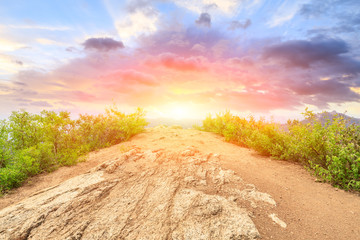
0, 0, 360, 121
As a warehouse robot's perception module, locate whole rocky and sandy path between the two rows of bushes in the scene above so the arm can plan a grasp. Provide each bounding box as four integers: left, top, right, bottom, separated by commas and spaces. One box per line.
0, 128, 360, 239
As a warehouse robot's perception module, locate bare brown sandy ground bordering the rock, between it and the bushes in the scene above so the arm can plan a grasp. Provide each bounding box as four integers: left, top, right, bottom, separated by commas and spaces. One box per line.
0, 128, 360, 239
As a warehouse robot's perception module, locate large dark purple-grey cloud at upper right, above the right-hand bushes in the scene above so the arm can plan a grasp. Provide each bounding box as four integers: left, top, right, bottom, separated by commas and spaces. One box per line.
263, 39, 349, 68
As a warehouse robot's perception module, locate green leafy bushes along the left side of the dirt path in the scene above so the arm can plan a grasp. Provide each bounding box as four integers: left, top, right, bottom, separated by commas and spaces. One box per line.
0, 106, 148, 194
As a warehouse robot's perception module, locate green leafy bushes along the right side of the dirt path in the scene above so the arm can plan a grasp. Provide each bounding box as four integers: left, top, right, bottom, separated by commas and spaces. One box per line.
197, 109, 360, 191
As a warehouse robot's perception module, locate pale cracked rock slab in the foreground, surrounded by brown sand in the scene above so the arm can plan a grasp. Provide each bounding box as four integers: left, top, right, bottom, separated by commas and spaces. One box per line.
0, 147, 276, 240
